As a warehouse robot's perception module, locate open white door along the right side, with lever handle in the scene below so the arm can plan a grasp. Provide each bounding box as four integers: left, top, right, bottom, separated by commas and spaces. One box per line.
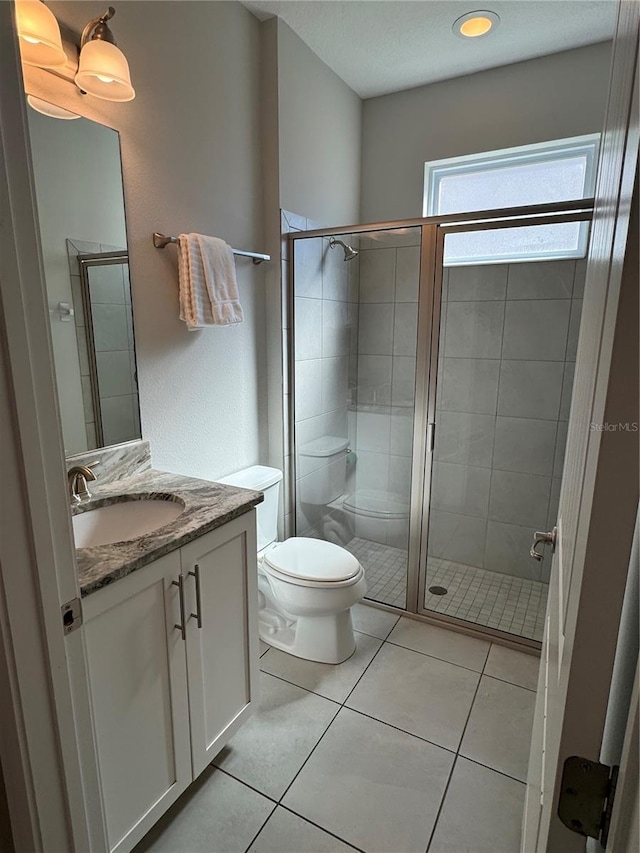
522, 2, 640, 853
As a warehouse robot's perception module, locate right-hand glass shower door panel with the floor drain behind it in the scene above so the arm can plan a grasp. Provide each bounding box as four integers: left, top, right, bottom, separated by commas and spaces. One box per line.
419, 214, 587, 640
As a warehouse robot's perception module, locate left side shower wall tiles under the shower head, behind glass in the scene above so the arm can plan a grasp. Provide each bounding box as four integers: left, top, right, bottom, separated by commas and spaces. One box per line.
285, 223, 358, 542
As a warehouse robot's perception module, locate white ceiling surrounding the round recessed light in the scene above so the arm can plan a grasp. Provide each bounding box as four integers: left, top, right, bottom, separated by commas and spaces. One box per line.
243, 0, 617, 98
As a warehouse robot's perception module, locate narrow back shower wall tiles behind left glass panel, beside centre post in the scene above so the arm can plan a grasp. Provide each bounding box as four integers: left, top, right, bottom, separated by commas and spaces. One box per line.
352, 229, 420, 548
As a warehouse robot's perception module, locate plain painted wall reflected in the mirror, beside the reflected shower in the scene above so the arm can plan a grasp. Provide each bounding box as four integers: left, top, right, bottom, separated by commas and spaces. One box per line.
29, 115, 126, 460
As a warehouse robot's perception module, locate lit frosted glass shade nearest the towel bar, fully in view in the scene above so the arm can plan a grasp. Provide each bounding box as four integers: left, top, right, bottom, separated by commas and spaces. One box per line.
76, 39, 136, 101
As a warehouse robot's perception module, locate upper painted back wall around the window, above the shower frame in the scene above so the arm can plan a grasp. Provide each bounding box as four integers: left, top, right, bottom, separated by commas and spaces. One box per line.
360, 42, 611, 222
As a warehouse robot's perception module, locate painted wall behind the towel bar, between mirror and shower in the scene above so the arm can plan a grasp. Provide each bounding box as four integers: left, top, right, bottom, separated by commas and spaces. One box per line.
28, 0, 266, 478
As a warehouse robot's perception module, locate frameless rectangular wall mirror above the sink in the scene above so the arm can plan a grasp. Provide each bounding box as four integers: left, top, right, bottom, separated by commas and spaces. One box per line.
29, 99, 140, 454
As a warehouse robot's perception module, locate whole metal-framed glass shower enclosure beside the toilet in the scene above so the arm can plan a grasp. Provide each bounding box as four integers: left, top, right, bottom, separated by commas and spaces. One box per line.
289, 202, 591, 643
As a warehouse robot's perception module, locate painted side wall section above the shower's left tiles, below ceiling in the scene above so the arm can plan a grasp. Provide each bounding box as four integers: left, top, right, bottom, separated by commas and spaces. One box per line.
277, 20, 362, 226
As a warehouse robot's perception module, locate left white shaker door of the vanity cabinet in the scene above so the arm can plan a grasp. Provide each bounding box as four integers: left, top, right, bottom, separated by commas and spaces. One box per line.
83, 551, 192, 853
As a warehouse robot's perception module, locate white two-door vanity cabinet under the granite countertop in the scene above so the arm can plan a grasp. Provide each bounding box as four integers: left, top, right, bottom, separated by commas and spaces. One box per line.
83, 510, 259, 853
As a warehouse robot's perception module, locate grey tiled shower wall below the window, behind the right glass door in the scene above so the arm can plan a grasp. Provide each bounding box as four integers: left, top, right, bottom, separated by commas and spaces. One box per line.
429, 261, 585, 581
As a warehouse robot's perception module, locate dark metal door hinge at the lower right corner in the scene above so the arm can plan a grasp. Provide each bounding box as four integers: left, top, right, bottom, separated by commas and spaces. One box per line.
558, 755, 619, 847
